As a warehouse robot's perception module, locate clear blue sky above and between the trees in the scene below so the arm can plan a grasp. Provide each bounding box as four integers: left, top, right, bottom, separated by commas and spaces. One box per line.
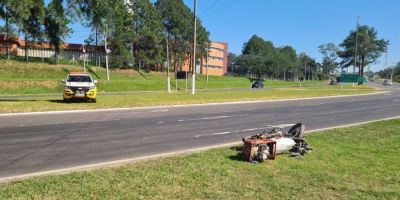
1, 0, 400, 71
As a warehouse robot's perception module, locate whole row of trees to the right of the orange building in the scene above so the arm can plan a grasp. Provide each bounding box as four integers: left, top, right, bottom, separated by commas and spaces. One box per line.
228, 25, 389, 81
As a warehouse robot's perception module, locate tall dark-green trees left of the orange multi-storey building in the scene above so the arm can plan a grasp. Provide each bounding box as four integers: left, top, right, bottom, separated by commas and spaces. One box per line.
0, 0, 210, 70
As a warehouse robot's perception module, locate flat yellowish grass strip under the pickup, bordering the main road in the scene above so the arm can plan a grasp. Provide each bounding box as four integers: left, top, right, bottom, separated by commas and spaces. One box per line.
0, 86, 375, 113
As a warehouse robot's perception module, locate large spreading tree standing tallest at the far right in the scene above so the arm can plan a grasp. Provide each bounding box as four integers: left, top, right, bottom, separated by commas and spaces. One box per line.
338, 25, 389, 80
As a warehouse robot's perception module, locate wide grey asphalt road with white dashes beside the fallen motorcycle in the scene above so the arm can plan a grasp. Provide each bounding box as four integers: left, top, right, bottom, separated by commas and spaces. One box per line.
0, 85, 400, 178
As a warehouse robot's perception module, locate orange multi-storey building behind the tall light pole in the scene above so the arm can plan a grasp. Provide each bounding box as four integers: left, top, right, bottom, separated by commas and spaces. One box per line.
182, 42, 228, 76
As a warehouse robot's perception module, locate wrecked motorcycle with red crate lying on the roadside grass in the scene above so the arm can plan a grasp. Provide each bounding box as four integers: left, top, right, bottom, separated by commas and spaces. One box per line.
242, 123, 312, 163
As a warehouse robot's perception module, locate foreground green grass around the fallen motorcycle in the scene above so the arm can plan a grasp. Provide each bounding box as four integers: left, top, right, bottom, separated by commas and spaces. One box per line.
0, 120, 400, 199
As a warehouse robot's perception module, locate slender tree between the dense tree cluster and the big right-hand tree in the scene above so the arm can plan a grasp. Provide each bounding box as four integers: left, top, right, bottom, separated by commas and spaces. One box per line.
318, 43, 339, 78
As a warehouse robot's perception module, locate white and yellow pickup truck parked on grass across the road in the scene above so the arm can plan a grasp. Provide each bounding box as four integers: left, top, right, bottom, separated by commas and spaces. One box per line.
62, 72, 97, 103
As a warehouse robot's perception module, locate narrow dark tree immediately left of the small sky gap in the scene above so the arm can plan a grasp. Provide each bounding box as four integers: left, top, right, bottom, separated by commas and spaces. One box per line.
44, 0, 71, 63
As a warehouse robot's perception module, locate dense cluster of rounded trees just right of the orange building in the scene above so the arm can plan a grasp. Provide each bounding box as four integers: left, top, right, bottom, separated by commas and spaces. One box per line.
228, 35, 322, 80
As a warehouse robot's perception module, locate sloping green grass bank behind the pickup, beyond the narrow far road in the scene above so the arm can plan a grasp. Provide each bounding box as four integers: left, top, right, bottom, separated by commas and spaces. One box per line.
0, 59, 322, 95
